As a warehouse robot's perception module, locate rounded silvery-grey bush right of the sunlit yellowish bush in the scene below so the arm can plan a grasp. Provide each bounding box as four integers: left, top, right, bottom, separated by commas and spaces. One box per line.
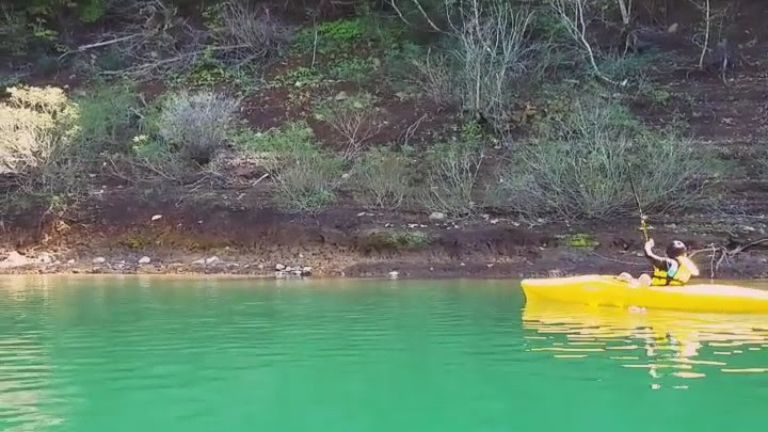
158, 92, 240, 164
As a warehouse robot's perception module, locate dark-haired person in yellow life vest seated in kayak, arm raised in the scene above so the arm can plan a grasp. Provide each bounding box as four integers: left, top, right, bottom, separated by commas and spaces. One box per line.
619, 239, 699, 286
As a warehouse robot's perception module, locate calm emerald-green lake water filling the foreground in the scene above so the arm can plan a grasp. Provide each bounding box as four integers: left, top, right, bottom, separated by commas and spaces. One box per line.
0, 277, 768, 432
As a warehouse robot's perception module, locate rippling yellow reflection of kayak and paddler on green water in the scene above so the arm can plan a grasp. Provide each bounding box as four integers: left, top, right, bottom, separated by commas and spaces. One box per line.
523, 302, 768, 385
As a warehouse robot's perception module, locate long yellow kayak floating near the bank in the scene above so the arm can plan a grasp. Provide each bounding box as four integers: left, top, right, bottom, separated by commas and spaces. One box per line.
521, 275, 768, 313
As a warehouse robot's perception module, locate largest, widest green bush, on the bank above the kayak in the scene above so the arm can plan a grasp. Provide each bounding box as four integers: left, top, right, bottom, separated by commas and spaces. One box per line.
496, 96, 708, 220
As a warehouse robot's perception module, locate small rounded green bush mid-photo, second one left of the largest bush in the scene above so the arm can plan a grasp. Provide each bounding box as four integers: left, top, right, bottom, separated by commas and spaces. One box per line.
354, 148, 413, 209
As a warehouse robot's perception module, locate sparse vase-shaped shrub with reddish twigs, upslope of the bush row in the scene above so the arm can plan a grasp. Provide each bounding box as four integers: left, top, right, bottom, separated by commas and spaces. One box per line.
315, 93, 382, 159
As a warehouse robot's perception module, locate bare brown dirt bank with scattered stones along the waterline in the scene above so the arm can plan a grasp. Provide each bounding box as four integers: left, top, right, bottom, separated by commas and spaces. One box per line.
0, 189, 768, 278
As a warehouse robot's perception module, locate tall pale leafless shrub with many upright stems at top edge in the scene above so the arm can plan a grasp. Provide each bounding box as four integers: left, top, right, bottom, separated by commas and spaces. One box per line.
392, 0, 534, 129
